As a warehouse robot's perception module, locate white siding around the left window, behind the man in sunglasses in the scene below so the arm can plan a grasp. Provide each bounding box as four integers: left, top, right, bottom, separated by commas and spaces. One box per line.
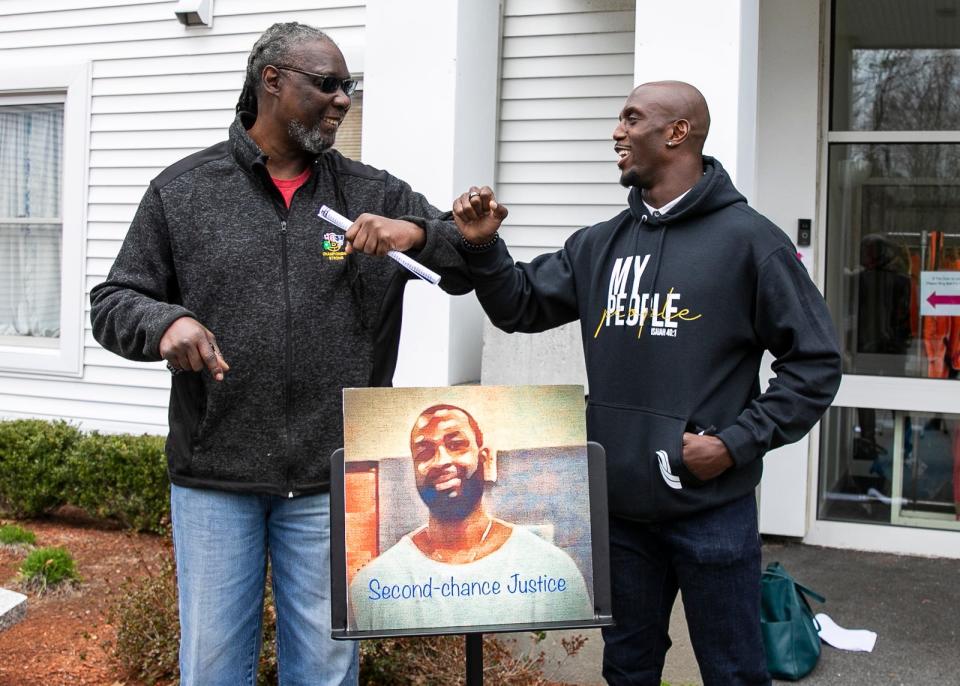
0, 0, 366, 433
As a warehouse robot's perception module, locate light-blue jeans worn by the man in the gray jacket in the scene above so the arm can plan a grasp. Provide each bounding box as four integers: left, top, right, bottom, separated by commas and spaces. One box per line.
170, 486, 359, 686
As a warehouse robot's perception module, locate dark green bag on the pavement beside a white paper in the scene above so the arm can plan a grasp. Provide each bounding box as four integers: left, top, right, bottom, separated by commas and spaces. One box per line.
760, 562, 826, 681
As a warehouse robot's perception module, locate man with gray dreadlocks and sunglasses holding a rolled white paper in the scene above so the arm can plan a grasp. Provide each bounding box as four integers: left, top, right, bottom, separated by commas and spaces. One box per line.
90, 23, 469, 686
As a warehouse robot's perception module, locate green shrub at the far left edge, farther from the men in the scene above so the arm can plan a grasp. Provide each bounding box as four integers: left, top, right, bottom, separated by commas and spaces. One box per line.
0, 419, 80, 518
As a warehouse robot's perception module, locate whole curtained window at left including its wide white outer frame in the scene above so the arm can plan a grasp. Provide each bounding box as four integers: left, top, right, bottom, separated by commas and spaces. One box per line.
0, 63, 90, 376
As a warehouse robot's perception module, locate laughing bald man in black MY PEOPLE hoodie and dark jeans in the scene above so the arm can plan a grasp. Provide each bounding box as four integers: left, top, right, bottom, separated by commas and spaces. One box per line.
454, 82, 840, 686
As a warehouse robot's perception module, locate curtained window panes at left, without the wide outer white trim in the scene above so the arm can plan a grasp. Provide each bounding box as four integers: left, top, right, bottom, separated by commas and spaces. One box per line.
0, 96, 64, 347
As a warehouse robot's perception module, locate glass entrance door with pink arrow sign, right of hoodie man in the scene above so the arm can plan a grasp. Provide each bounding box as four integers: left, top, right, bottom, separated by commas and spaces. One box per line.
818, 0, 960, 530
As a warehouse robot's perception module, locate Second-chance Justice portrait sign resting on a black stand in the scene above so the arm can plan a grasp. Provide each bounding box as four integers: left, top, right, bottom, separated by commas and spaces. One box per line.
330, 386, 612, 639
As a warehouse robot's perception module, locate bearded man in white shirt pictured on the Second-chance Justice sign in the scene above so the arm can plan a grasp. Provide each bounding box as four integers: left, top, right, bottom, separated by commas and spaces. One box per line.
350, 405, 594, 630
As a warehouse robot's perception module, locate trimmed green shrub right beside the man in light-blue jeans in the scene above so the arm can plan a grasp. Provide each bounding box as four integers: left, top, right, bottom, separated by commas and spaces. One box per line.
66, 432, 170, 533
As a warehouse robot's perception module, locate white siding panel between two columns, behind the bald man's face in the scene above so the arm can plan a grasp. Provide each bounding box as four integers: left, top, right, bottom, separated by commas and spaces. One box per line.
495, 0, 635, 259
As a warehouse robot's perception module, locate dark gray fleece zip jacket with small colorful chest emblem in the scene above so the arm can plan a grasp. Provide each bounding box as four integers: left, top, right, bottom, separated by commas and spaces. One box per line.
90, 118, 470, 497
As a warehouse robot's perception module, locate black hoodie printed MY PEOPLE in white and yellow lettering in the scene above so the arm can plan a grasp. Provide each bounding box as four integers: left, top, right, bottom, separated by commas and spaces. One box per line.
466, 157, 840, 521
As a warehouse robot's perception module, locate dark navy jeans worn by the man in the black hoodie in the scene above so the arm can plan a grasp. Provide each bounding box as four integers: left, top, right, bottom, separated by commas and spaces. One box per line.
603, 493, 770, 686
